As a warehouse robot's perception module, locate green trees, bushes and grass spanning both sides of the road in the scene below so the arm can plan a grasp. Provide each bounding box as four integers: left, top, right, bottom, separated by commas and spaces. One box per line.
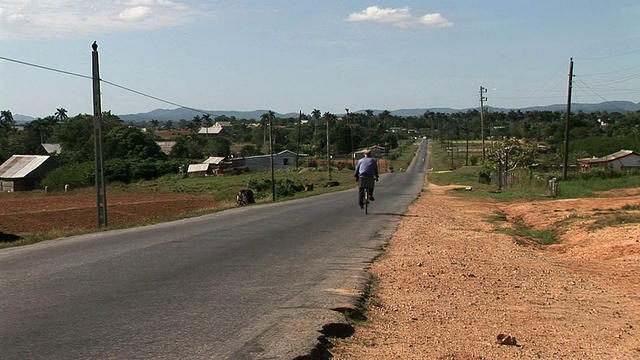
0, 108, 640, 246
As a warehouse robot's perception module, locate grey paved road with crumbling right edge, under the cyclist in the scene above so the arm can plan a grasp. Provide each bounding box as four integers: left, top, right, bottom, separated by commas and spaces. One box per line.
0, 141, 426, 360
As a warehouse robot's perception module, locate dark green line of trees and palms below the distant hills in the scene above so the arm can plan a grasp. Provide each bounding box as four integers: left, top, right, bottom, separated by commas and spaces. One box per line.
0, 108, 640, 188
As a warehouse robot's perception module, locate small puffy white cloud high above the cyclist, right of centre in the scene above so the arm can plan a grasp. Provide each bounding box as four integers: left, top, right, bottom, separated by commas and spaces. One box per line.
346, 6, 453, 29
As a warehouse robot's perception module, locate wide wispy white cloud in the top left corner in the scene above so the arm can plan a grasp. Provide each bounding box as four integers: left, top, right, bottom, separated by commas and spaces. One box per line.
0, 0, 210, 40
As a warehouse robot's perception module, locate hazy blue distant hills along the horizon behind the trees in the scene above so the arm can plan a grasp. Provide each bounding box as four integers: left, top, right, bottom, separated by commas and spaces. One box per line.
13, 101, 640, 123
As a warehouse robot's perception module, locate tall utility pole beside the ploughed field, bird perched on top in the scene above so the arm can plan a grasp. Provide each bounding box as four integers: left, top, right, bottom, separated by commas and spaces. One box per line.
91, 41, 107, 228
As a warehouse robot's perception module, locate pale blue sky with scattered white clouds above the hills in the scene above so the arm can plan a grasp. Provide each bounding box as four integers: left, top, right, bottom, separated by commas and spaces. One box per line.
0, 0, 640, 117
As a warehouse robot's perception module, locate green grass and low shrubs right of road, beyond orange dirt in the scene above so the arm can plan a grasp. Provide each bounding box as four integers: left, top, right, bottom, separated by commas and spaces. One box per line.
428, 140, 640, 245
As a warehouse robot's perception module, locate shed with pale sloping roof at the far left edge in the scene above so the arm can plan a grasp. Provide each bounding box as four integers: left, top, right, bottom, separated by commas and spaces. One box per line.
0, 155, 59, 191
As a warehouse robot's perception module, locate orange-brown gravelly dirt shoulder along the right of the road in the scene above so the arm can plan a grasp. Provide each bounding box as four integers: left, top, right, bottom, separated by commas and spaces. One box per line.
330, 185, 640, 359
